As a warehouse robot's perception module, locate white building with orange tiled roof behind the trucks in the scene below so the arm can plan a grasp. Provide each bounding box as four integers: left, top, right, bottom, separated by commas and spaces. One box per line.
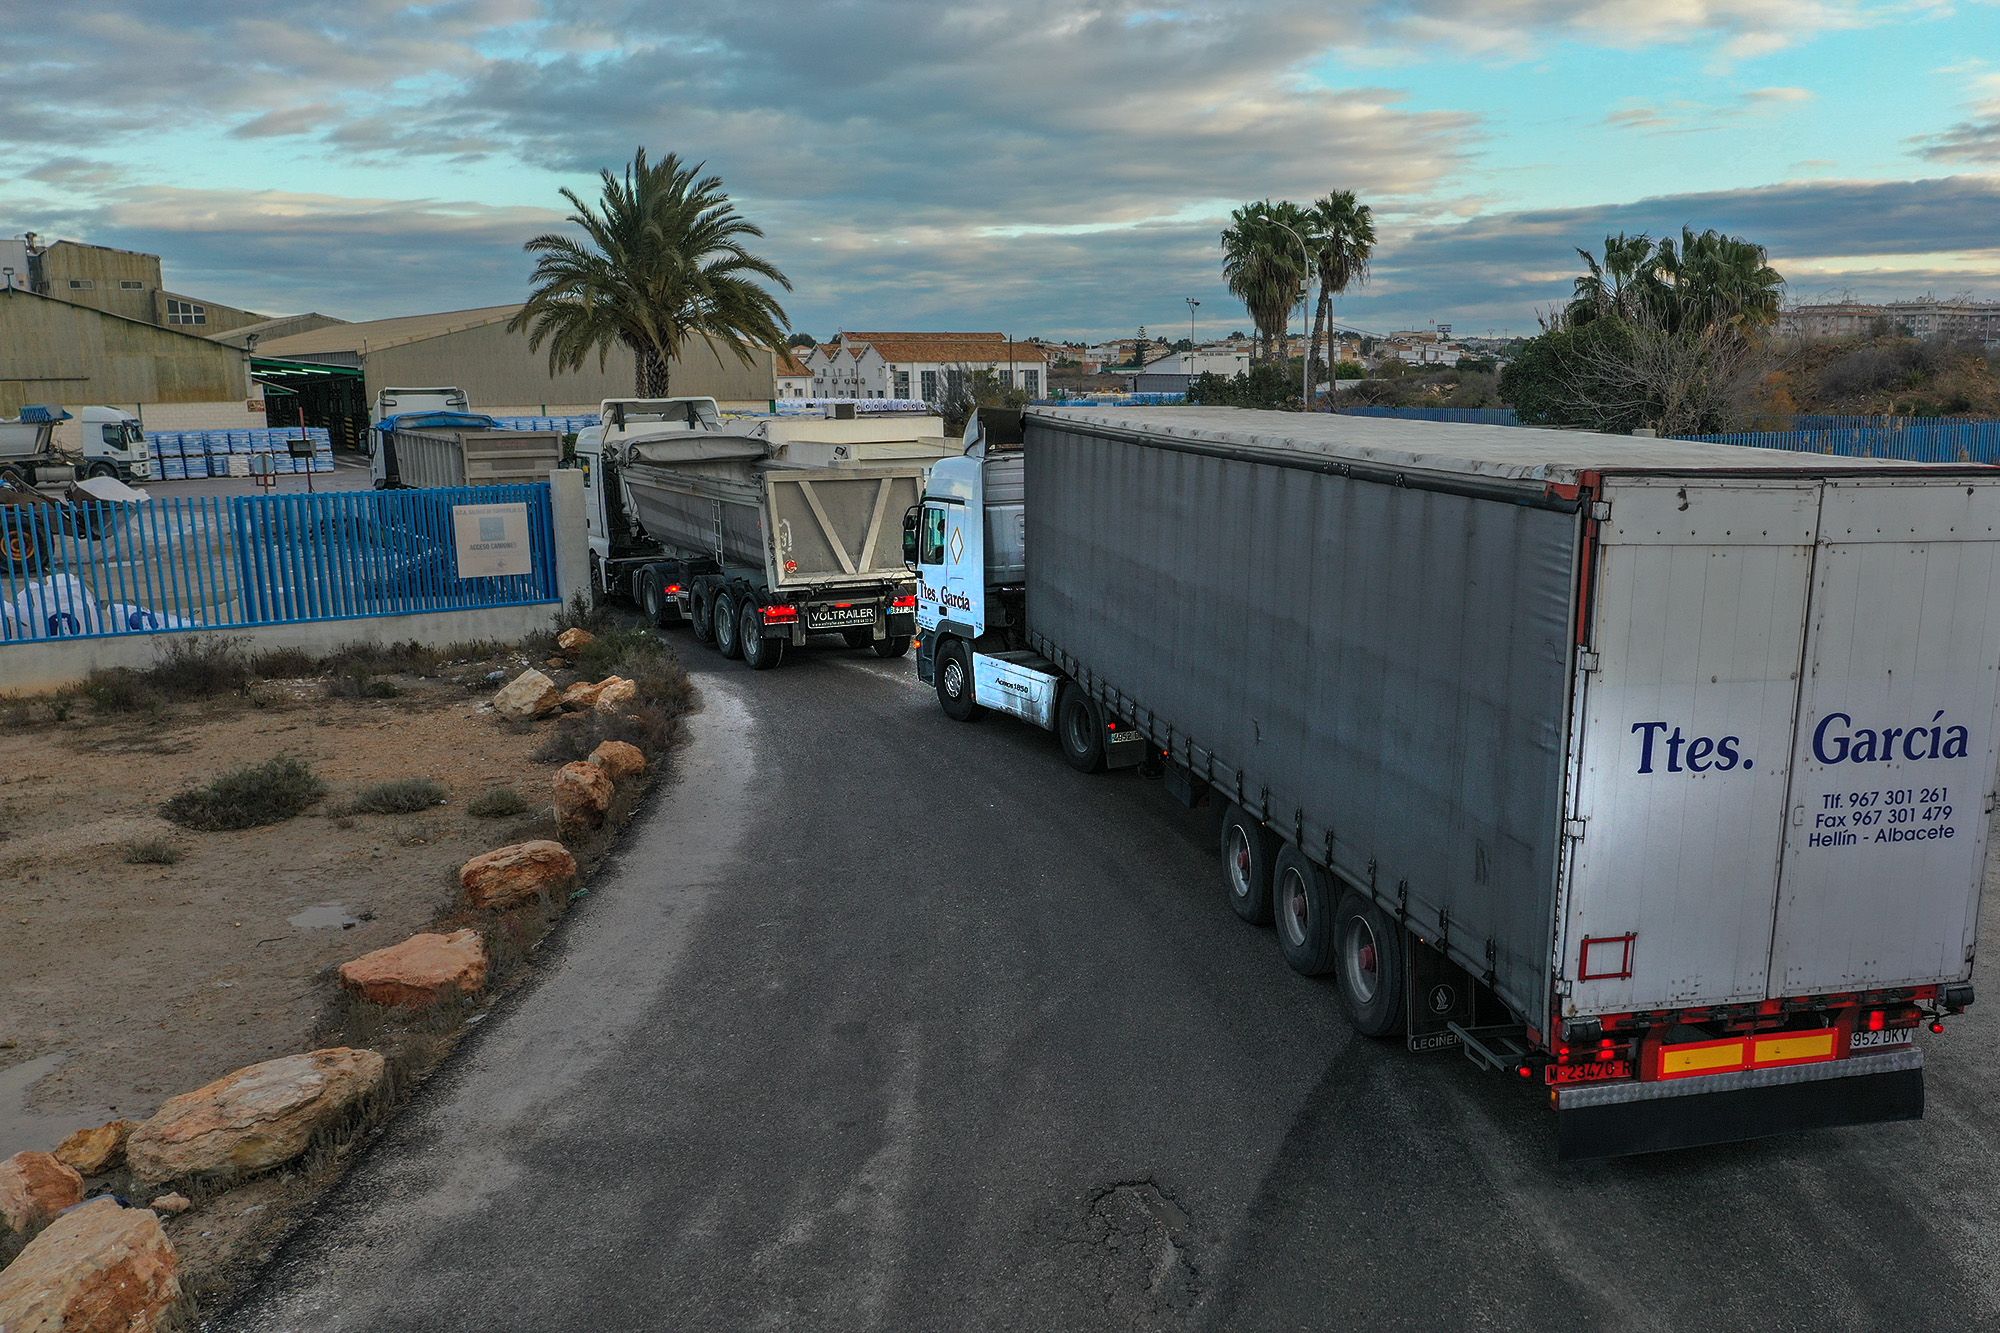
800, 332, 1048, 402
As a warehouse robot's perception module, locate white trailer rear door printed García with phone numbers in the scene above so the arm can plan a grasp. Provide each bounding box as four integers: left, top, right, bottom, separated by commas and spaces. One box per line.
1770, 478, 2000, 995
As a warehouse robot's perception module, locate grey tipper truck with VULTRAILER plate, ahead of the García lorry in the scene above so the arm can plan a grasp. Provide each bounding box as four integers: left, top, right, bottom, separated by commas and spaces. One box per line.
576, 398, 924, 671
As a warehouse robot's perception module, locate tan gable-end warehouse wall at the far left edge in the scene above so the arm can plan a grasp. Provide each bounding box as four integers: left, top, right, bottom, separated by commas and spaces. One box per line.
0, 288, 250, 416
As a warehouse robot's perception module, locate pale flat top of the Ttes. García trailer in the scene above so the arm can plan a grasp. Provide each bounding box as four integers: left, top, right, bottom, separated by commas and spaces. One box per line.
1028, 406, 1992, 484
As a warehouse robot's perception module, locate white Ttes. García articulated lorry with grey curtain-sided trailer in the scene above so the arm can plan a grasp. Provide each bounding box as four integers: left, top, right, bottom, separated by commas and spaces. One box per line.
906, 408, 2000, 1157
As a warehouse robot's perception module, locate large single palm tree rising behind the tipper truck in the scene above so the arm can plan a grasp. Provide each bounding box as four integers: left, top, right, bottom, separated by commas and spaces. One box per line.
508, 148, 792, 398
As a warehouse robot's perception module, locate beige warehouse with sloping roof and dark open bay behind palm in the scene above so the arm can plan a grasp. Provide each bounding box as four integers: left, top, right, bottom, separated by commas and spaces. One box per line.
250, 304, 796, 436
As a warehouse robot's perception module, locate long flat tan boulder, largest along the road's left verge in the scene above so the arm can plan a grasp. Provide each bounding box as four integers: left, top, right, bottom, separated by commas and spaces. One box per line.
126, 1047, 382, 1185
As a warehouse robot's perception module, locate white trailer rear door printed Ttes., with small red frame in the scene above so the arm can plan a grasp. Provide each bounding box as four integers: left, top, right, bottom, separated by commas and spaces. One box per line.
1556, 478, 1818, 1015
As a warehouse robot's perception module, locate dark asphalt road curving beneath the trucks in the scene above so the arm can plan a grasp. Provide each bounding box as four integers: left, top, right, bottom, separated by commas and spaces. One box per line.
220, 638, 2000, 1333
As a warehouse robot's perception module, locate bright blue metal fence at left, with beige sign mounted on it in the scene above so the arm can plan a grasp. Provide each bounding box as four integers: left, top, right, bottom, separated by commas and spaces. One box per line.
0, 482, 560, 640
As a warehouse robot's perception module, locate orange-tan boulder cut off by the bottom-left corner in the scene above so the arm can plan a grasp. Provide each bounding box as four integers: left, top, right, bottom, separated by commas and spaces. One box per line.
0, 1197, 180, 1333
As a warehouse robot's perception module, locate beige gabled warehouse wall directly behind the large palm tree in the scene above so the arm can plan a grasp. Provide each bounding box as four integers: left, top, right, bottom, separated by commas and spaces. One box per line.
368, 322, 776, 412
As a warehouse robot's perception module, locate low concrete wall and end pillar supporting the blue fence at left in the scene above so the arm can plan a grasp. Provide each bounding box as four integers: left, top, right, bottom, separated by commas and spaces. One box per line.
0, 470, 590, 697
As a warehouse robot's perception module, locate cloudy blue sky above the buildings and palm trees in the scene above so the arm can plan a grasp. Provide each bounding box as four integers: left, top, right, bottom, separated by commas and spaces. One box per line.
0, 0, 2000, 338
